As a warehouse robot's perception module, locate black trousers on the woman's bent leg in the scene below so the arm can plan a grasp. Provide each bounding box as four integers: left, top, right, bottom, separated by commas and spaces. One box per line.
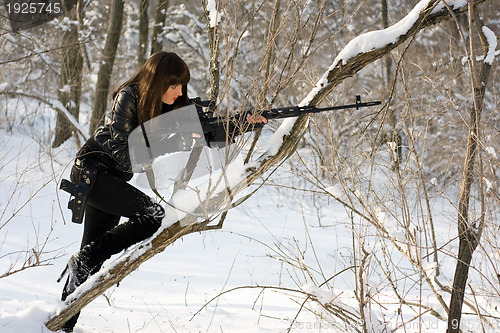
62, 162, 165, 331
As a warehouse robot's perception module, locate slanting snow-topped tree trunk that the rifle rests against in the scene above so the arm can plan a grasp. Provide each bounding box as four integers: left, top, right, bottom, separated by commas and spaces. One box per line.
46, 0, 484, 330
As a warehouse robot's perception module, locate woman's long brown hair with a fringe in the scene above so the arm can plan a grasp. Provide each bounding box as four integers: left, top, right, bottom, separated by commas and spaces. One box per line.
113, 51, 191, 123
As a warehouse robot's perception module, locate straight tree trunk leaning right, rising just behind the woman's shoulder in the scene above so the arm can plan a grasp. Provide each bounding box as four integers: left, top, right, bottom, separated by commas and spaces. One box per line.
90, 0, 124, 135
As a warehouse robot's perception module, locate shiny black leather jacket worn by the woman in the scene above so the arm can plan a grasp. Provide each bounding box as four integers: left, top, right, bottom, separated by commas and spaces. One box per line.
78, 85, 139, 178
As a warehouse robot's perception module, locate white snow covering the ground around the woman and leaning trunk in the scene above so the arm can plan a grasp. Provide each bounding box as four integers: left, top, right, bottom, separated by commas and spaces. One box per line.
0, 115, 496, 333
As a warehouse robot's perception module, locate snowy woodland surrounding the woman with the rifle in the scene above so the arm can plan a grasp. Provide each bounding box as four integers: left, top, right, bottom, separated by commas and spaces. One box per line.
0, 0, 500, 333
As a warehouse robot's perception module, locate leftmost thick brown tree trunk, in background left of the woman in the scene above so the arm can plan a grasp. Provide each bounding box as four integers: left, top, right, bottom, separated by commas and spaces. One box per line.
52, 1, 83, 147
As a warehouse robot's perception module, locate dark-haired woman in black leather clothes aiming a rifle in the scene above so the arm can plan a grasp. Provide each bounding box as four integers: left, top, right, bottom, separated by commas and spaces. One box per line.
62, 52, 190, 332
